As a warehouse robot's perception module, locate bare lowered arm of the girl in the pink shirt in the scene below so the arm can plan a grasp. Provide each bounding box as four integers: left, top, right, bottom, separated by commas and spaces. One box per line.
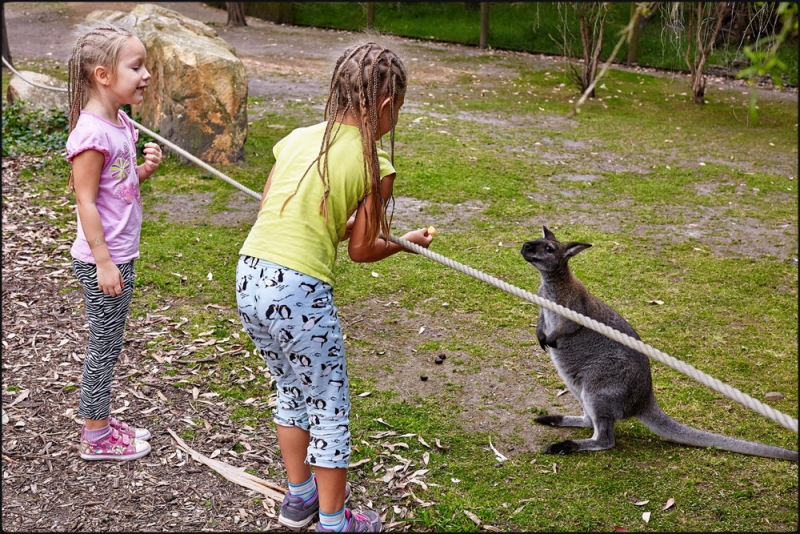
72, 150, 125, 297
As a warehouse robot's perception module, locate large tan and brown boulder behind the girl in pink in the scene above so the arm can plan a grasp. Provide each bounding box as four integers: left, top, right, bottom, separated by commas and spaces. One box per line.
87, 4, 247, 164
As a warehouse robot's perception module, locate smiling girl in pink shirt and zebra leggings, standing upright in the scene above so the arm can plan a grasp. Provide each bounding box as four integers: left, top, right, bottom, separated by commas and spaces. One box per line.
67, 22, 161, 460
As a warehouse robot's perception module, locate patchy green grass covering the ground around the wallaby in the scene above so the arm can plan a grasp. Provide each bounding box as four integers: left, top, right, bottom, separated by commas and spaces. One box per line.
3, 27, 798, 532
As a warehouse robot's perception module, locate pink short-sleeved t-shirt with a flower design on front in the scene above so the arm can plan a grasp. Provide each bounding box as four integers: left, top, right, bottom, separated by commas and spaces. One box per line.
67, 111, 142, 265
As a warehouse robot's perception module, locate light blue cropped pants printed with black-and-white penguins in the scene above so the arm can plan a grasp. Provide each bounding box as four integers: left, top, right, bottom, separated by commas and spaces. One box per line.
236, 255, 350, 468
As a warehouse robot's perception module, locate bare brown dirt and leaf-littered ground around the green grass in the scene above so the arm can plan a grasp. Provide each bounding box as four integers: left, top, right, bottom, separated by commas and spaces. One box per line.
2, 2, 797, 531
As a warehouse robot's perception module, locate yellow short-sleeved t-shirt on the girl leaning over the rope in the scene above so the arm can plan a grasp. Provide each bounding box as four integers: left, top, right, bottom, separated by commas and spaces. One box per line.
239, 122, 395, 285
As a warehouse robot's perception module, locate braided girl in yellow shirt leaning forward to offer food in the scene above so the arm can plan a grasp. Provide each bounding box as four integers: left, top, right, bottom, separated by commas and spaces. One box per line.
236, 42, 433, 532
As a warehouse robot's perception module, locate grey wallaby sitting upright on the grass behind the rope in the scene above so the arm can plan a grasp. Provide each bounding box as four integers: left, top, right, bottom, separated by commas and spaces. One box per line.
520, 227, 798, 462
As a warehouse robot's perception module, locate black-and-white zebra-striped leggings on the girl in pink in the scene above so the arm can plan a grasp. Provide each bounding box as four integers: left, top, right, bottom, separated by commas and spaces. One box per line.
72, 258, 136, 419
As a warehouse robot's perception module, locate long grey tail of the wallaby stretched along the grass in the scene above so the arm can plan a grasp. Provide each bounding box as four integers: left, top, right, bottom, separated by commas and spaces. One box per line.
637, 397, 798, 462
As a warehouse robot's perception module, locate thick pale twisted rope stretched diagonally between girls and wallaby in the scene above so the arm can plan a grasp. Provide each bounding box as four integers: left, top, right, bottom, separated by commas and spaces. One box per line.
3, 58, 798, 433
